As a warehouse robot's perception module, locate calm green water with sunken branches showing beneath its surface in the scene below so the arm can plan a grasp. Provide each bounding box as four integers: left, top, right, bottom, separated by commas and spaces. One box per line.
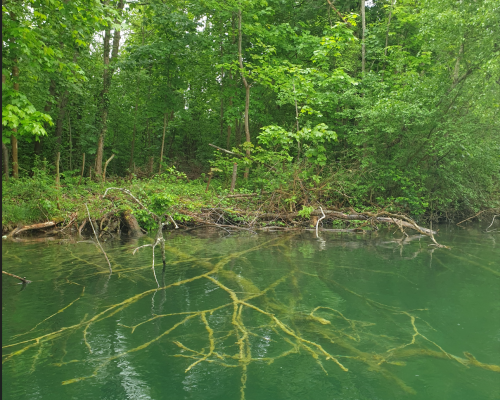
2, 227, 500, 400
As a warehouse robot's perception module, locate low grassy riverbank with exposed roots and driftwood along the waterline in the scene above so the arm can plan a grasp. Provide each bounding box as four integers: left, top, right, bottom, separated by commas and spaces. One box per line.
2, 169, 498, 236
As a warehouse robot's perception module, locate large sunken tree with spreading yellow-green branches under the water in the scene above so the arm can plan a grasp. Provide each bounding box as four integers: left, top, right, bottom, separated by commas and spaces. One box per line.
3, 236, 500, 399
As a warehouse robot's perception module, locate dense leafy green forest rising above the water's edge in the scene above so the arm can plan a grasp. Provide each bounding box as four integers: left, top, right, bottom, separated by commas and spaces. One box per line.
2, 0, 500, 231
